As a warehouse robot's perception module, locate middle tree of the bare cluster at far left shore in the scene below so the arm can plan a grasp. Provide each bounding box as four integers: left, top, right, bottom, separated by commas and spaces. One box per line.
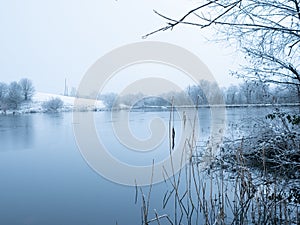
6, 81, 23, 109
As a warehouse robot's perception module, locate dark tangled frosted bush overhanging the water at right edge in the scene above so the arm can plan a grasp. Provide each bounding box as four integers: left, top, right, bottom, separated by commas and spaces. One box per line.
224, 109, 300, 179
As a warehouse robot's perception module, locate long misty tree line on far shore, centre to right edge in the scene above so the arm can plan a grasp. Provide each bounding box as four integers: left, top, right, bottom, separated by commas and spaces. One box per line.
99, 80, 300, 109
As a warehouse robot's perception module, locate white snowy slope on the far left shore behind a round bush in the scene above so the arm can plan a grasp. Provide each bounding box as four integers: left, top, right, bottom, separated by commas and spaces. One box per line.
2, 92, 105, 114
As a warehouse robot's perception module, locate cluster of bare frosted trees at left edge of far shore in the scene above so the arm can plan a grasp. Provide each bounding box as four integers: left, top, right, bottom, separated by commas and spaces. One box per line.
0, 78, 35, 112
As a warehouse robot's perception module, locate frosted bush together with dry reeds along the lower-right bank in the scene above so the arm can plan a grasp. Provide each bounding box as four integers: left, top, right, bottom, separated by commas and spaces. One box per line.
136, 104, 300, 225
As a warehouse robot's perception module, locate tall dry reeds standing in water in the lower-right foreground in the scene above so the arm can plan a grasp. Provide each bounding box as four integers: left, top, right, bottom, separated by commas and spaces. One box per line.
137, 103, 300, 225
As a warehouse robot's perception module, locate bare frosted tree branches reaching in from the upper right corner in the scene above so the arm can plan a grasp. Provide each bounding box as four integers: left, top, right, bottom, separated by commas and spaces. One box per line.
145, 0, 300, 99
